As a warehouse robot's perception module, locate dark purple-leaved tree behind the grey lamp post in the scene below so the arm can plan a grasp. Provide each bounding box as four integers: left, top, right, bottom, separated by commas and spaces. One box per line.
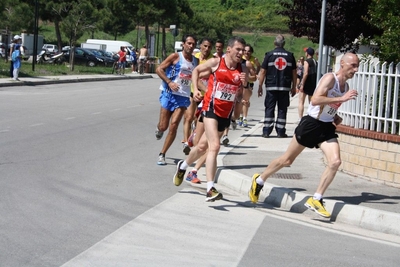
279, 0, 380, 51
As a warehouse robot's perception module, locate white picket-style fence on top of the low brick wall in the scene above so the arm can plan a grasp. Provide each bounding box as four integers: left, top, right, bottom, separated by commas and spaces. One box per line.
338, 62, 400, 135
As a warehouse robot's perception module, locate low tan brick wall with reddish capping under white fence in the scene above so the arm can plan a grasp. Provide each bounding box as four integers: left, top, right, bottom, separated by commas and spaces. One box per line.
337, 125, 400, 188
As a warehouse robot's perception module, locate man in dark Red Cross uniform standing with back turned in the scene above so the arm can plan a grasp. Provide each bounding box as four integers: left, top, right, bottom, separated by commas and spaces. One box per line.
258, 34, 297, 138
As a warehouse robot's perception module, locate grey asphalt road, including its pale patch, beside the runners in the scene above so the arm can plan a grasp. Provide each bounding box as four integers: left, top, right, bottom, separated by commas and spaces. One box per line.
0, 79, 400, 266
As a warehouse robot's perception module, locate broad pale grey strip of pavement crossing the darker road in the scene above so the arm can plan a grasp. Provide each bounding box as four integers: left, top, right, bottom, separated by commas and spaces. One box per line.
62, 188, 265, 267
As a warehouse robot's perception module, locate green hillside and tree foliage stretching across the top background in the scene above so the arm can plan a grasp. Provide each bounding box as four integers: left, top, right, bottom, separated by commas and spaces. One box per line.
0, 0, 400, 62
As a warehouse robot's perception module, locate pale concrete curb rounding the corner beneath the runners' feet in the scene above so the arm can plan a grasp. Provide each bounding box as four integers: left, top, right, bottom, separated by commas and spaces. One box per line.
215, 123, 400, 236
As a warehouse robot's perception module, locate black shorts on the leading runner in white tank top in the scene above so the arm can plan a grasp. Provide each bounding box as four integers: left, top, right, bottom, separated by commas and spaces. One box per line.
294, 115, 338, 148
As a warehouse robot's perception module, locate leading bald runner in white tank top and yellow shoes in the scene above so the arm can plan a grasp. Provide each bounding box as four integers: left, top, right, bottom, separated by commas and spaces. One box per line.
249, 53, 359, 218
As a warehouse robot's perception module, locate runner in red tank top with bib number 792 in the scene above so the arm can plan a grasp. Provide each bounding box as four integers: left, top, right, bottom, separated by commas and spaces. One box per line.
173, 37, 248, 201
